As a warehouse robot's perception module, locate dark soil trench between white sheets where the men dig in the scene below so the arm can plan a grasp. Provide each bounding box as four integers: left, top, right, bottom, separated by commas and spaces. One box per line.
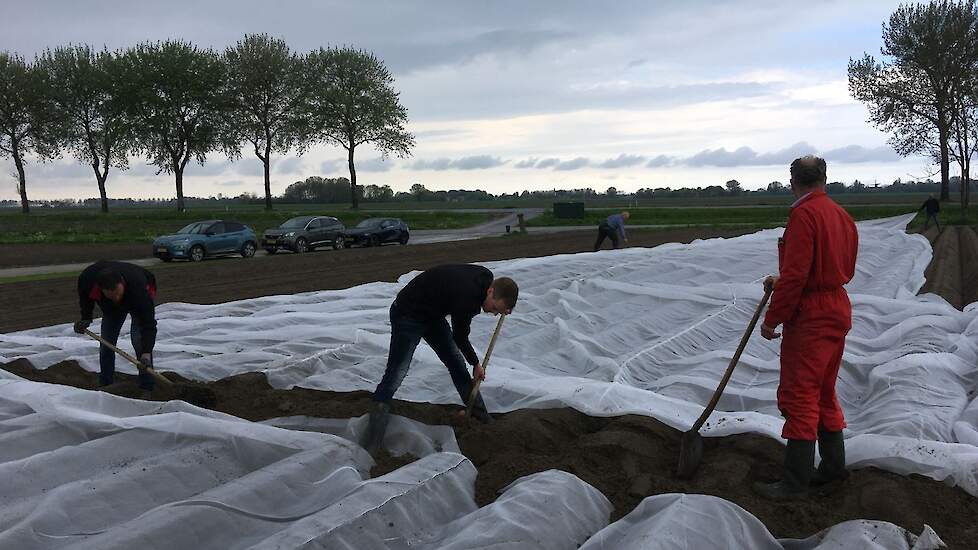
3, 360, 978, 548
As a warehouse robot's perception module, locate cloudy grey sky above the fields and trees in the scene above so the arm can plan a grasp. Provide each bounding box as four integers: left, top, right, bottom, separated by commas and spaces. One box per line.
0, 0, 934, 203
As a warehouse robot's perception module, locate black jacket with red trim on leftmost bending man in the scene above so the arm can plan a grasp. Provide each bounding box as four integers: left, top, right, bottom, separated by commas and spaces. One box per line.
78, 260, 156, 353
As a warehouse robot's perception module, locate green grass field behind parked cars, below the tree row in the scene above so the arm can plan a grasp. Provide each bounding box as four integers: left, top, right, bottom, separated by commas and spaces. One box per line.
0, 205, 491, 244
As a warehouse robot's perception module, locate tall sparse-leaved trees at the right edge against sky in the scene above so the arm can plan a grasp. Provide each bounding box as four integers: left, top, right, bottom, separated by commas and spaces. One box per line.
849, 0, 978, 213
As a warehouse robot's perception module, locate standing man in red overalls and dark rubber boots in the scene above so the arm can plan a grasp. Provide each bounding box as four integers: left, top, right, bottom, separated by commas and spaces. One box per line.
754, 156, 859, 500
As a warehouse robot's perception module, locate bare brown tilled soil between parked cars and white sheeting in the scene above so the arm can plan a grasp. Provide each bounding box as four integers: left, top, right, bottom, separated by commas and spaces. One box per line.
0, 228, 752, 332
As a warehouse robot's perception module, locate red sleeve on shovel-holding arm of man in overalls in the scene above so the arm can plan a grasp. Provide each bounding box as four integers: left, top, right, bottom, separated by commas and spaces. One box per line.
764, 209, 815, 328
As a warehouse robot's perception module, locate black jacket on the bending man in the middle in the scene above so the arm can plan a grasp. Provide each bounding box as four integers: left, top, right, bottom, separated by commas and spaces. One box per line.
395, 264, 493, 365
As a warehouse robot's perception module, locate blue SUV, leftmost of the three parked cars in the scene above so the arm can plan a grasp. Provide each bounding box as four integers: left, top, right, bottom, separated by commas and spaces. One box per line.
153, 220, 258, 262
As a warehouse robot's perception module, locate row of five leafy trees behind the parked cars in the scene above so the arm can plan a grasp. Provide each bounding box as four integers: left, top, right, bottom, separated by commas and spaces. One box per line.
0, 34, 414, 213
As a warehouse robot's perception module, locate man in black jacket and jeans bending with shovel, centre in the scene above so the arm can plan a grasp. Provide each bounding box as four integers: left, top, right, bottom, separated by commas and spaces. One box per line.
361, 265, 519, 453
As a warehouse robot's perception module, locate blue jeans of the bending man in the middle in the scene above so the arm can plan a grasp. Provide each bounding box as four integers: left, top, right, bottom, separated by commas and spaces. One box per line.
373, 302, 485, 410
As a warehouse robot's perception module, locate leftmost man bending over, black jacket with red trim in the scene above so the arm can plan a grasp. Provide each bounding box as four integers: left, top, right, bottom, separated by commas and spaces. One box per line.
74, 260, 156, 397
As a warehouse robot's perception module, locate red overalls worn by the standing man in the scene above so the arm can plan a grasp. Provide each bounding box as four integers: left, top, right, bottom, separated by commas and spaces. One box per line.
764, 191, 859, 441
